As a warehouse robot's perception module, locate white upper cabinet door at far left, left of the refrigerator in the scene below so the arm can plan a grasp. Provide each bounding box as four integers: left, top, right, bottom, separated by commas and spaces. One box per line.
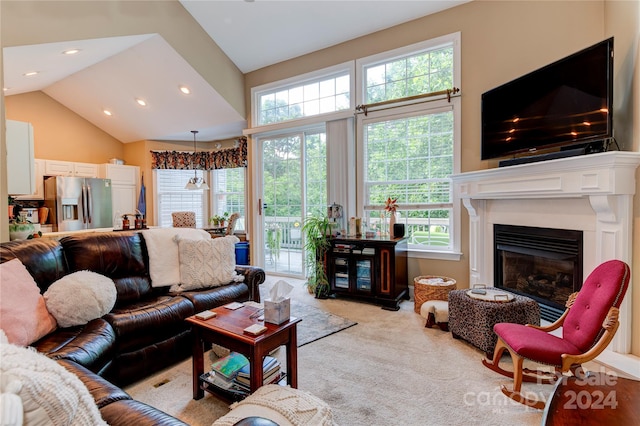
5, 120, 35, 195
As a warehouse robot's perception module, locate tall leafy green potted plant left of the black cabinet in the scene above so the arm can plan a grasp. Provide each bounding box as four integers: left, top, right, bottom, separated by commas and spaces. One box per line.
302, 216, 331, 299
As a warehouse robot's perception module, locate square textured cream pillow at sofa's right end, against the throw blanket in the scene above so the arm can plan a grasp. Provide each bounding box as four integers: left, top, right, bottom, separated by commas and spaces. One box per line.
171, 235, 244, 291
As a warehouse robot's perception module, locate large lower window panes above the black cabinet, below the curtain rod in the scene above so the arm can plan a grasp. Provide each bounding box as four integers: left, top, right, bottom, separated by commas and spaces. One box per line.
363, 107, 455, 250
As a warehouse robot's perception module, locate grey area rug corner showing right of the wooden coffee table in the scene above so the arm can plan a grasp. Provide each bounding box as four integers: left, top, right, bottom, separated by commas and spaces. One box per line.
291, 300, 357, 347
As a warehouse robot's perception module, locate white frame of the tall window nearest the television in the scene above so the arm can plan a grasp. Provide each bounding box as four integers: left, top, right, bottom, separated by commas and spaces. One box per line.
355, 32, 462, 260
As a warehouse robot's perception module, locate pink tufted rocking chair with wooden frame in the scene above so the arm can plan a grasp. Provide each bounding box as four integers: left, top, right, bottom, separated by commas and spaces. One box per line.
482, 260, 630, 409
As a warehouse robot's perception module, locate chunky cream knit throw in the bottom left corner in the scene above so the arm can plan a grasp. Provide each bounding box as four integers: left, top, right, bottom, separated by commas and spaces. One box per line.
0, 333, 107, 426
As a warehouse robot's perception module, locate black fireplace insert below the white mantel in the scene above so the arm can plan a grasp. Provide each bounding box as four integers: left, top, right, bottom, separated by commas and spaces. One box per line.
493, 224, 582, 322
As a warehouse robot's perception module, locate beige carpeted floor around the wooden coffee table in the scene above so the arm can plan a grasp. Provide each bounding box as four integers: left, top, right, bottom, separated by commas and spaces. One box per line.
126, 280, 551, 426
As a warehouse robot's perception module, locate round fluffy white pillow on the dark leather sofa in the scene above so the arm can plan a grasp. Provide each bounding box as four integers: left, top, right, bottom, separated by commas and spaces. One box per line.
44, 271, 118, 327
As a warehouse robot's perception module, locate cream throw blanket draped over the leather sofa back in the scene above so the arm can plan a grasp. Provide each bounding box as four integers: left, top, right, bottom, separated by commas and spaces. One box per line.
142, 228, 211, 287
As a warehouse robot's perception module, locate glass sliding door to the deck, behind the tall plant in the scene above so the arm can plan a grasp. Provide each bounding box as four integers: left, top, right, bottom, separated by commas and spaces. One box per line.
258, 130, 327, 277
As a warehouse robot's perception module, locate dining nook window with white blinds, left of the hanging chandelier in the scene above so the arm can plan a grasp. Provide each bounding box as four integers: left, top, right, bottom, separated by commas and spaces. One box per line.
155, 169, 208, 228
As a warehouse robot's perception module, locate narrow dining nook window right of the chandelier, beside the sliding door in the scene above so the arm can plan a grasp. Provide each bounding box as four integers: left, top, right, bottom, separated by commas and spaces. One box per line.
211, 167, 246, 231
